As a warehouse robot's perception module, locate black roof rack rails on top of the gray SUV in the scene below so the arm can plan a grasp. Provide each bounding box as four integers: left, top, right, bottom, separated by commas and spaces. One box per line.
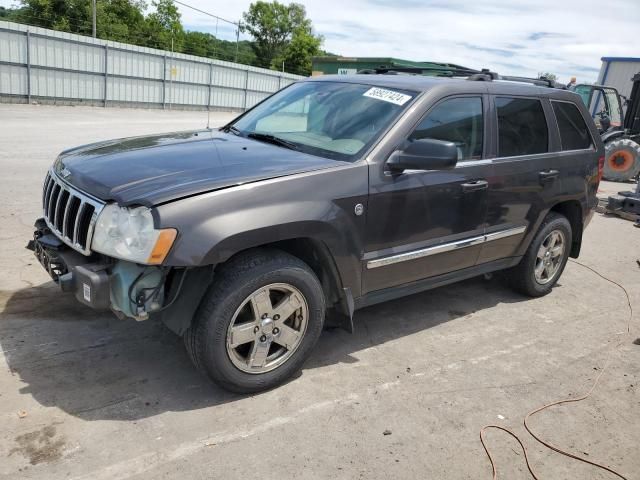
358, 66, 567, 90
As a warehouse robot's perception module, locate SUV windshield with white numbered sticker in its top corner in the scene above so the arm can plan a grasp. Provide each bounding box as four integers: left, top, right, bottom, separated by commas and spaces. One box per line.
227, 82, 416, 161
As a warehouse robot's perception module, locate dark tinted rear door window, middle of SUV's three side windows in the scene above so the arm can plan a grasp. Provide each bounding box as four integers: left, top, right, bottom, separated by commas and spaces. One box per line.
496, 97, 549, 157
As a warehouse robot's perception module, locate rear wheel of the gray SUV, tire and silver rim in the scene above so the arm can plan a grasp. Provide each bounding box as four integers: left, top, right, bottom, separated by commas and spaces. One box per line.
507, 212, 572, 297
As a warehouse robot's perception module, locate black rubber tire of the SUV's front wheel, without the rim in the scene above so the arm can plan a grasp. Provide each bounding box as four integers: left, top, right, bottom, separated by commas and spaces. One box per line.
198, 264, 325, 393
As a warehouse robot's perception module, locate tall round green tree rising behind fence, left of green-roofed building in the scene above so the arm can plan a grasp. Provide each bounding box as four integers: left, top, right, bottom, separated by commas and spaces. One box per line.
242, 0, 322, 68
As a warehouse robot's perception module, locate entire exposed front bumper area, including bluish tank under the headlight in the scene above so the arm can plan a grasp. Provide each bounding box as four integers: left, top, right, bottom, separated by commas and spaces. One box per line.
27, 219, 169, 320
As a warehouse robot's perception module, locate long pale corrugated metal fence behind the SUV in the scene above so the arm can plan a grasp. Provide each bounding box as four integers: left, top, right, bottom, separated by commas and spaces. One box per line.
0, 22, 303, 110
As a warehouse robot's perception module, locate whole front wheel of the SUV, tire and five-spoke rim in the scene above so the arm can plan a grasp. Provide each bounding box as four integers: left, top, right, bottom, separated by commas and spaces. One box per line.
184, 249, 325, 393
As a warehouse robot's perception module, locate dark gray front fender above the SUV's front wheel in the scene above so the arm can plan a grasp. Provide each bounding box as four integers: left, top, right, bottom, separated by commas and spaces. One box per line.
157, 162, 368, 296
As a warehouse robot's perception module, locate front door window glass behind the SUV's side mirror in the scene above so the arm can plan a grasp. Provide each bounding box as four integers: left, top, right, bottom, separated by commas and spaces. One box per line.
409, 97, 484, 161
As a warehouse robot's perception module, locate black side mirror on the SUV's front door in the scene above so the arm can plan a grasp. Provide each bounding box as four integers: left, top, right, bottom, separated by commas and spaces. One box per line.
387, 138, 458, 173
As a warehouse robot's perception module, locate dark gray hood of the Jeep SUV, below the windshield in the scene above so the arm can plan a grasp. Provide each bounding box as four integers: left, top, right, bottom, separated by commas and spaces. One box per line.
54, 130, 344, 206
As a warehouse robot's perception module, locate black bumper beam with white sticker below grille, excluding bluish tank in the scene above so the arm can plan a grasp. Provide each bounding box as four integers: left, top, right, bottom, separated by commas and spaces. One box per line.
27, 219, 112, 310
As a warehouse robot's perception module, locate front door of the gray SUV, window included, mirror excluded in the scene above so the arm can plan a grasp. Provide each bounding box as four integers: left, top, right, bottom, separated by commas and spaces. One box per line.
363, 95, 488, 293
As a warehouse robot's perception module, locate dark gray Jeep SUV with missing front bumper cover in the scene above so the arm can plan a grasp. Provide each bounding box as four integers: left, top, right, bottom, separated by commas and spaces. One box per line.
29, 75, 604, 392
